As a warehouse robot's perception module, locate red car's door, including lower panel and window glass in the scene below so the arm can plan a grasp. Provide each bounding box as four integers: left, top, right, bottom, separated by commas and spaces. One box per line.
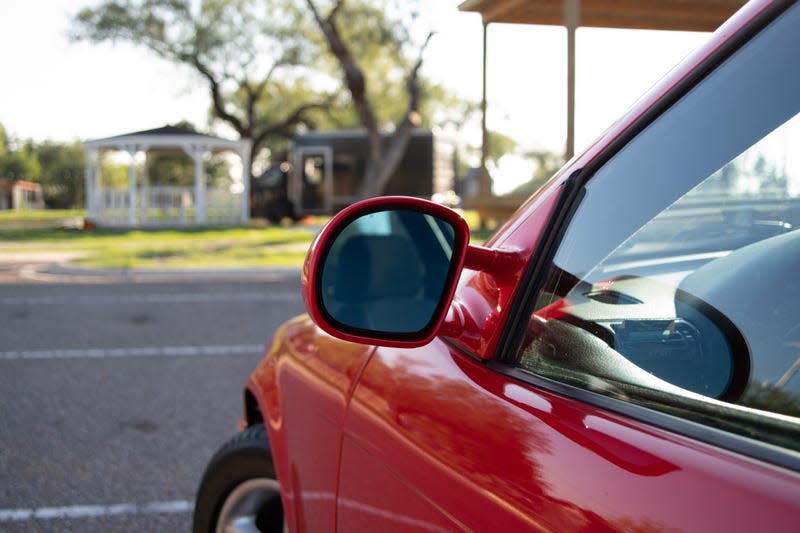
337, 5, 800, 531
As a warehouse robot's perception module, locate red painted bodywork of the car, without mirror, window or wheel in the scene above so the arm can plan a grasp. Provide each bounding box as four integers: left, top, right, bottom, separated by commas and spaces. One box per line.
205, 1, 800, 532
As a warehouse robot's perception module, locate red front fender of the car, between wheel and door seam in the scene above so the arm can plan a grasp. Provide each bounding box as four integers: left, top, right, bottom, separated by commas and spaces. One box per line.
247, 316, 374, 531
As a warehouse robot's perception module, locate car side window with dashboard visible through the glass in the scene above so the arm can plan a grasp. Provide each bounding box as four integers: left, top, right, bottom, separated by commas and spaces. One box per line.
517, 7, 800, 449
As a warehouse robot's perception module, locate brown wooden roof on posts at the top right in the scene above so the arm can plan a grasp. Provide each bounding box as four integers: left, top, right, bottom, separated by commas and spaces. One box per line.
458, 0, 746, 32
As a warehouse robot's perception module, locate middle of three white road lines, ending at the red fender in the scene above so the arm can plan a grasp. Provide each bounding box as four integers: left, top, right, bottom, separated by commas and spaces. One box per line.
0, 344, 264, 361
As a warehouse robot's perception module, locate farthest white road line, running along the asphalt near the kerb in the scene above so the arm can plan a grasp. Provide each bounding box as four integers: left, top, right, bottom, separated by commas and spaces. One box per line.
0, 289, 300, 305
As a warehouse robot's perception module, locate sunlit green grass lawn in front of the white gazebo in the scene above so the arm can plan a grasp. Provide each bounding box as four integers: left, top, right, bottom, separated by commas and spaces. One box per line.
0, 210, 494, 269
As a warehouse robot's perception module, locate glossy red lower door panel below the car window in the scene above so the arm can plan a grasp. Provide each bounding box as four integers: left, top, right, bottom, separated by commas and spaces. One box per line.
338, 341, 800, 531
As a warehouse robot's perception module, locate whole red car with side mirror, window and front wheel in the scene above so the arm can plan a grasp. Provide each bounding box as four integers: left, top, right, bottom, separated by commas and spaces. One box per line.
194, 1, 800, 532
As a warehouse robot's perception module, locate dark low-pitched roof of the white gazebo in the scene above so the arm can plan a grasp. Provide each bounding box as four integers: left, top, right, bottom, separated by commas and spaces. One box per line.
83, 125, 249, 151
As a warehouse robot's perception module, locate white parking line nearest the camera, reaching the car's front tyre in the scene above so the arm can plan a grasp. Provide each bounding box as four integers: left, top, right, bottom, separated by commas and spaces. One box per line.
0, 500, 194, 523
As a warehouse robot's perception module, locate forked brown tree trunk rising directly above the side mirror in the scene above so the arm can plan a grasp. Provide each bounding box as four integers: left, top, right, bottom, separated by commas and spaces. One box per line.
306, 0, 432, 196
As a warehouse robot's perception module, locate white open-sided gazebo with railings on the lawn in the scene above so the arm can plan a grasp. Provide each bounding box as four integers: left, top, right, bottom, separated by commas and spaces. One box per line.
83, 126, 251, 227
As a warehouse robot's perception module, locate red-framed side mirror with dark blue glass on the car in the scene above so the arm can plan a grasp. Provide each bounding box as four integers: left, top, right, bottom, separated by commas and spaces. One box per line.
302, 197, 469, 347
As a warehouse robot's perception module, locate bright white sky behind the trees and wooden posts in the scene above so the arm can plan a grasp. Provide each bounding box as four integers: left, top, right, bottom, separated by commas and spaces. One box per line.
0, 0, 708, 192
